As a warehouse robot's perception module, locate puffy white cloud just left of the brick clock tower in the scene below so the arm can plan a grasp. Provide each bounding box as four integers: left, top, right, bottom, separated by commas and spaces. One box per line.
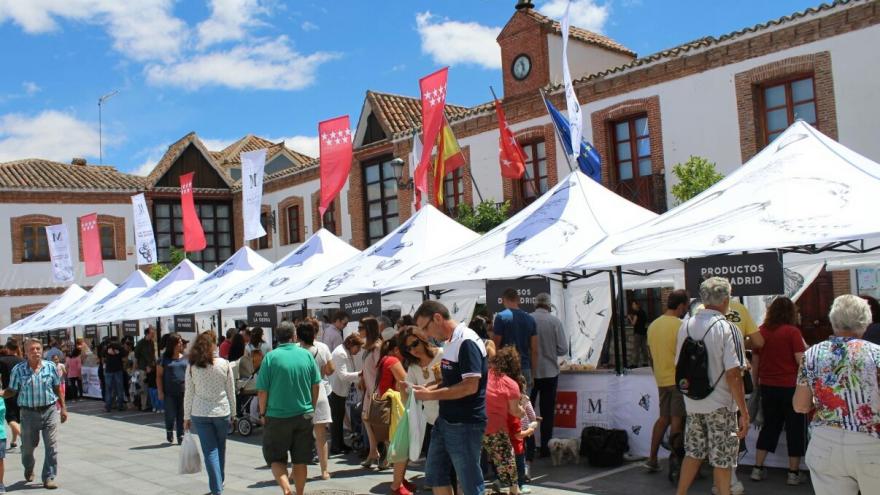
416, 12, 501, 69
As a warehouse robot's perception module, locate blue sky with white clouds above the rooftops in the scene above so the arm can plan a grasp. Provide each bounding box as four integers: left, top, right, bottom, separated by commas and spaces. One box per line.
0, 0, 819, 175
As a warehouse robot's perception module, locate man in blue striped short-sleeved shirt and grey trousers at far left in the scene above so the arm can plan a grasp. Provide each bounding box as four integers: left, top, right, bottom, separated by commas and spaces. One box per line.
3, 339, 67, 490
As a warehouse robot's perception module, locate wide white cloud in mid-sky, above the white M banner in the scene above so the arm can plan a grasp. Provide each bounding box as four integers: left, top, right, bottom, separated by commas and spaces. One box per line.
145, 36, 337, 90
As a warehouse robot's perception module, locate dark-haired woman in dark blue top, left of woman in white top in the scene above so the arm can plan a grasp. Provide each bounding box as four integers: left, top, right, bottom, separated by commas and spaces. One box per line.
156, 333, 187, 444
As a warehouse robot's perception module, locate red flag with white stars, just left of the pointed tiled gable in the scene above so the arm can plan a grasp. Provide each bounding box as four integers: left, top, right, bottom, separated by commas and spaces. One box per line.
318, 115, 354, 217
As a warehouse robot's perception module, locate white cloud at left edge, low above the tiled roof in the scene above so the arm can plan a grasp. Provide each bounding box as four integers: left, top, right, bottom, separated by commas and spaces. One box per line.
0, 110, 101, 163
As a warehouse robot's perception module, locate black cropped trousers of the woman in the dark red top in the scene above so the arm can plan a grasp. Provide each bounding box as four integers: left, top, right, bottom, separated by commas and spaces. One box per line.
757, 385, 807, 457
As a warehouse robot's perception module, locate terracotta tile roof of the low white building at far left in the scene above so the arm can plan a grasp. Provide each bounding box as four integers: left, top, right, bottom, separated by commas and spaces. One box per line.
0, 158, 145, 191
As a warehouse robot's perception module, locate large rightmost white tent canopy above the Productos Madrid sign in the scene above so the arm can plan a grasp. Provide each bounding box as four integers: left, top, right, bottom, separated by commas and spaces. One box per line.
570, 121, 880, 269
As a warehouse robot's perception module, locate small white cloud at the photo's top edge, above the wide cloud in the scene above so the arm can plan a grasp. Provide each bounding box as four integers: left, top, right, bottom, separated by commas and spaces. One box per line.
197, 0, 268, 48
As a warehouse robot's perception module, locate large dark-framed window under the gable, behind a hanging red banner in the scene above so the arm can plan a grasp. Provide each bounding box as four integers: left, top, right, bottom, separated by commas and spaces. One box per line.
153, 200, 234, 269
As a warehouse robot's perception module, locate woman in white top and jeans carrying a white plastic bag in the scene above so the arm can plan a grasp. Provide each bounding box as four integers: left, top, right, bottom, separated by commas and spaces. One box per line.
183, 332, 235, 495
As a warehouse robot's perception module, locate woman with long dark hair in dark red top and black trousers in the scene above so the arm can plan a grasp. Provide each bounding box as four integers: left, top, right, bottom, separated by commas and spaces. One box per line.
751, 297, 807, 485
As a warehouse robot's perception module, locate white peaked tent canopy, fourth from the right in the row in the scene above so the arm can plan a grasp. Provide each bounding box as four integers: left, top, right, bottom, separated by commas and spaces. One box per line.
209, 229, 360, 309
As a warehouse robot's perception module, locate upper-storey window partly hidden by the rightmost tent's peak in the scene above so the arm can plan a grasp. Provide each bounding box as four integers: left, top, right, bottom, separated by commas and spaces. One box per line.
760, 76, 816, 146
